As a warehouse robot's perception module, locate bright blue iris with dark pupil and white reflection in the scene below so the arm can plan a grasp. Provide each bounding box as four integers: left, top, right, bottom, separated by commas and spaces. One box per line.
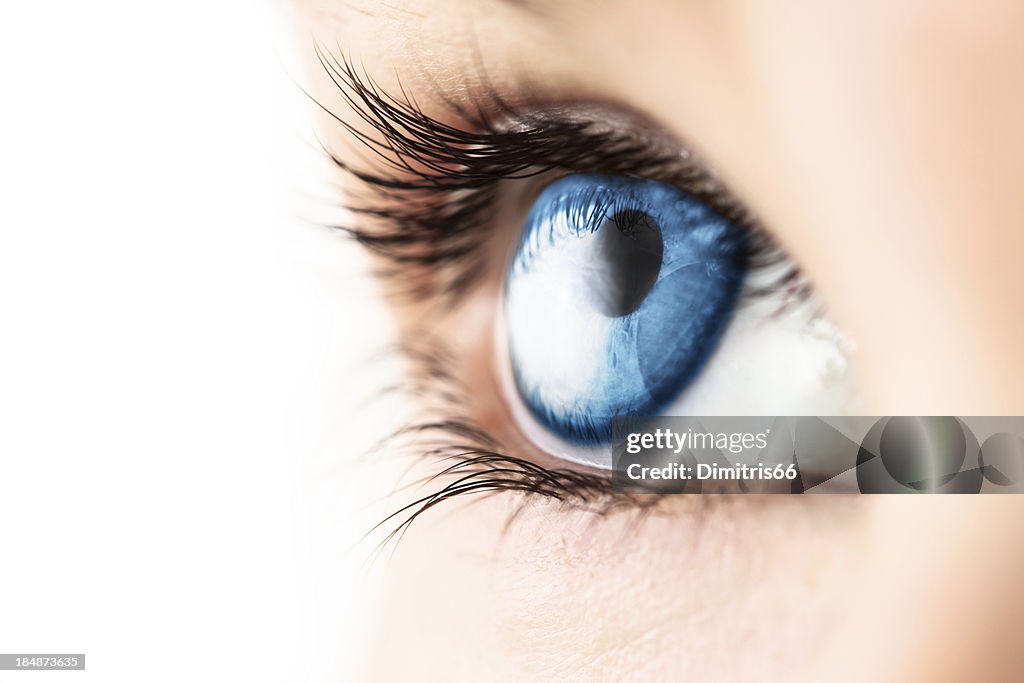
505, 174, 746, 444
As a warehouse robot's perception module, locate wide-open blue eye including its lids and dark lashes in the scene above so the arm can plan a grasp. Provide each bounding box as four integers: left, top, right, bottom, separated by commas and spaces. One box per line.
309, 50, 857, 497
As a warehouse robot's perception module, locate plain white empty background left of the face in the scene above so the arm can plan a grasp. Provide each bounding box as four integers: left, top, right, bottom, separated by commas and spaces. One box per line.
0, 0, 372, 682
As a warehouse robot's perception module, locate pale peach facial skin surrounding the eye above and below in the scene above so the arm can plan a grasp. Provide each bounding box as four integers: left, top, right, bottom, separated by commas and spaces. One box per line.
297, 0, 1024, 681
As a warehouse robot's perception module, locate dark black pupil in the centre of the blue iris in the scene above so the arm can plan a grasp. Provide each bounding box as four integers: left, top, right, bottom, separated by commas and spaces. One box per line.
585, 211, 665, 317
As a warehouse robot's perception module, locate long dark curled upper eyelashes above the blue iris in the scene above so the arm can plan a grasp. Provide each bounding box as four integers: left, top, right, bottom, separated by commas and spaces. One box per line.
307, 45, 809, 305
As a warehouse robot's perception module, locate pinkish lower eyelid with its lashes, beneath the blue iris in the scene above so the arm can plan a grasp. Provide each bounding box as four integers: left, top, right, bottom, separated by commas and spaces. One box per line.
362, 274, 856, 545
